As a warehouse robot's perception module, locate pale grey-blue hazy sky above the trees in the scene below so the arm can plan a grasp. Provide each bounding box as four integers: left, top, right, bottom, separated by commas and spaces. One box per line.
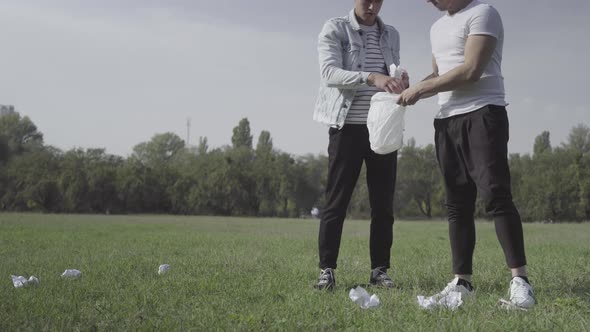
0, 0, 590, 156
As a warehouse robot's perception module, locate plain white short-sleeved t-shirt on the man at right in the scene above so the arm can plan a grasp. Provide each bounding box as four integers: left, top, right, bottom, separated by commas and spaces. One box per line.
430, 0, 507, 119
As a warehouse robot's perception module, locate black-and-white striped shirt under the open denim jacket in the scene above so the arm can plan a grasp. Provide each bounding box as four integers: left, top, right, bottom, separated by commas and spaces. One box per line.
344, 24, 388, 124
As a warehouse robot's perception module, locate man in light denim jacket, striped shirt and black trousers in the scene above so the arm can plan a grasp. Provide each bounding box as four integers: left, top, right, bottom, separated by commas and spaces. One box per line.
314, 0, 409, 289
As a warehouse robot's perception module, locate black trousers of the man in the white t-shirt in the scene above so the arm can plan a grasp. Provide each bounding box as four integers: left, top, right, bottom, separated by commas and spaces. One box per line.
434, 105, 526, 274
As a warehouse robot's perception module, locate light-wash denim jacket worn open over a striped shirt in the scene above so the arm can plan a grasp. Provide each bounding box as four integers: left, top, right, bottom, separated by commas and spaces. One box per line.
313, 9, 399, 128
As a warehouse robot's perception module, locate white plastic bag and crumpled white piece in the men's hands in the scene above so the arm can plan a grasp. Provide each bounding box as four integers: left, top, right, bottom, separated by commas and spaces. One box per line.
367, 65, 406, 154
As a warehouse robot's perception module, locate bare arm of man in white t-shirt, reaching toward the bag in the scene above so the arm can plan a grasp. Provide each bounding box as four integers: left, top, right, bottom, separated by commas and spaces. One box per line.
398, 35, 497, 105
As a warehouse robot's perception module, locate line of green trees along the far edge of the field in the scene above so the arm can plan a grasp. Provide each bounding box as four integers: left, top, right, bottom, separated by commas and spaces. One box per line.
0, 110, 590, 222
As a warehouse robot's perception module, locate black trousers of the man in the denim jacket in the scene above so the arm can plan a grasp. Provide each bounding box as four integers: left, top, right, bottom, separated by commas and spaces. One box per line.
319, 124, 397, 269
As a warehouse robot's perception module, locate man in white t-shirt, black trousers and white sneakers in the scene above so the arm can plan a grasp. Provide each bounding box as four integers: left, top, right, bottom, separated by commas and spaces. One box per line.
399, 0, 535, 308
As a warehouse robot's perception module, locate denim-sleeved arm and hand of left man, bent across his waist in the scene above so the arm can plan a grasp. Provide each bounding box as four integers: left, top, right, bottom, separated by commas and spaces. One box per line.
318, 22, 403, 93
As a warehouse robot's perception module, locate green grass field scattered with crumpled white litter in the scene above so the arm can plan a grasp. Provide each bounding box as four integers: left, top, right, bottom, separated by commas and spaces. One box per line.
0, 214, 590, 331
